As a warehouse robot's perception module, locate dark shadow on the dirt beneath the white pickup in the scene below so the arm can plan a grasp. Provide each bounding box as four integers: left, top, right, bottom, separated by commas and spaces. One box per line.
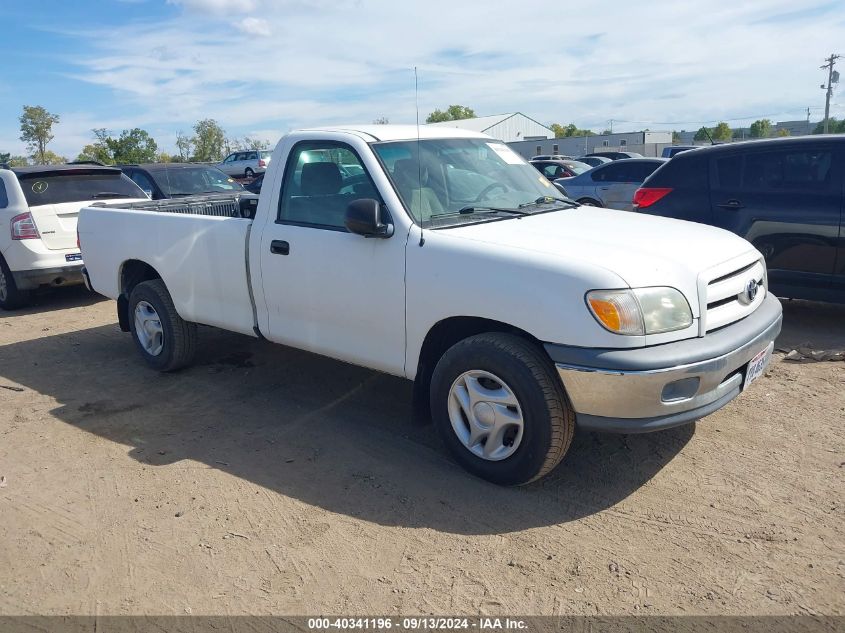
0, 325, 694, 534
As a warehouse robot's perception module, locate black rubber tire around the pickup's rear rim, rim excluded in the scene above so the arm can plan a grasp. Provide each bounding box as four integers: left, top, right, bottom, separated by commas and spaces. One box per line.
127, 279, 197, 371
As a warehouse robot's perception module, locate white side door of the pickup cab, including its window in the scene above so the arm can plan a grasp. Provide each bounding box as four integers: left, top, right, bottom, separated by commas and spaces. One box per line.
260, 141, 406, 375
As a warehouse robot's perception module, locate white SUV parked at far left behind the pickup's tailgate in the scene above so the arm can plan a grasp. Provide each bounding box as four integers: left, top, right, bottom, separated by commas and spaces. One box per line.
0, 165, 147, 310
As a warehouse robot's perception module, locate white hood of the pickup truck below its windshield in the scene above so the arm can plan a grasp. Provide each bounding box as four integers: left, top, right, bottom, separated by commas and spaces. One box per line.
448, 207, 762, 312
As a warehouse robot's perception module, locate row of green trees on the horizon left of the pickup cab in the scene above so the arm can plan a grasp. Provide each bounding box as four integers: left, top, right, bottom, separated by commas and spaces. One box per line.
0, 105, 270, 167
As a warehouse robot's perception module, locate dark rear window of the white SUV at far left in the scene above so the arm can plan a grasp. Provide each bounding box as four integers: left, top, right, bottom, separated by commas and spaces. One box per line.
18, 169, 147, 207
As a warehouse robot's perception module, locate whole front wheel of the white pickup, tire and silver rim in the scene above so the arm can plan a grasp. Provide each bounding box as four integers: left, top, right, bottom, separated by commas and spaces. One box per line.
430, 333, 575, 486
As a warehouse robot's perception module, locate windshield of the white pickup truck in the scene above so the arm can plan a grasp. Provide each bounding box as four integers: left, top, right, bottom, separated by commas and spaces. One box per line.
373, 138, 560, 226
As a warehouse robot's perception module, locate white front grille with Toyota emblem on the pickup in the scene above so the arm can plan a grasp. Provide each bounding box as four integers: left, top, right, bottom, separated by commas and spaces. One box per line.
704, 260, 766, 333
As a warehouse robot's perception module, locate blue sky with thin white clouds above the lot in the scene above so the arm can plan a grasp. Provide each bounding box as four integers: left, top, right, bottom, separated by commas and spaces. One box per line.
0, 0, 845, 158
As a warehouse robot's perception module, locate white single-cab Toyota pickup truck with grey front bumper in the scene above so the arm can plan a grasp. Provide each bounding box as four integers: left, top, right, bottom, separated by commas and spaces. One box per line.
79, 125, 781, 484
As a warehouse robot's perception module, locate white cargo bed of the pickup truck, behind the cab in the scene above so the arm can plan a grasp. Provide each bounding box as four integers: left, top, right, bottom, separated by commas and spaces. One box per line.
79, 199, 258, 336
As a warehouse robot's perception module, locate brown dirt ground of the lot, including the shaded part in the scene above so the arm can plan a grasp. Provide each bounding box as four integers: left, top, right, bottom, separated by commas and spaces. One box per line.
0, 289, 845, 615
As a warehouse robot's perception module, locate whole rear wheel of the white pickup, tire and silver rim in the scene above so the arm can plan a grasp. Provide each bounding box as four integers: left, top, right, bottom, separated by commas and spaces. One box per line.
128, 279, 197, 371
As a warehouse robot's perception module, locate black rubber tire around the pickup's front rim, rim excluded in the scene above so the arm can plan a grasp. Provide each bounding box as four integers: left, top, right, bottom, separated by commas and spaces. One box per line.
430, 333, 575, 486
